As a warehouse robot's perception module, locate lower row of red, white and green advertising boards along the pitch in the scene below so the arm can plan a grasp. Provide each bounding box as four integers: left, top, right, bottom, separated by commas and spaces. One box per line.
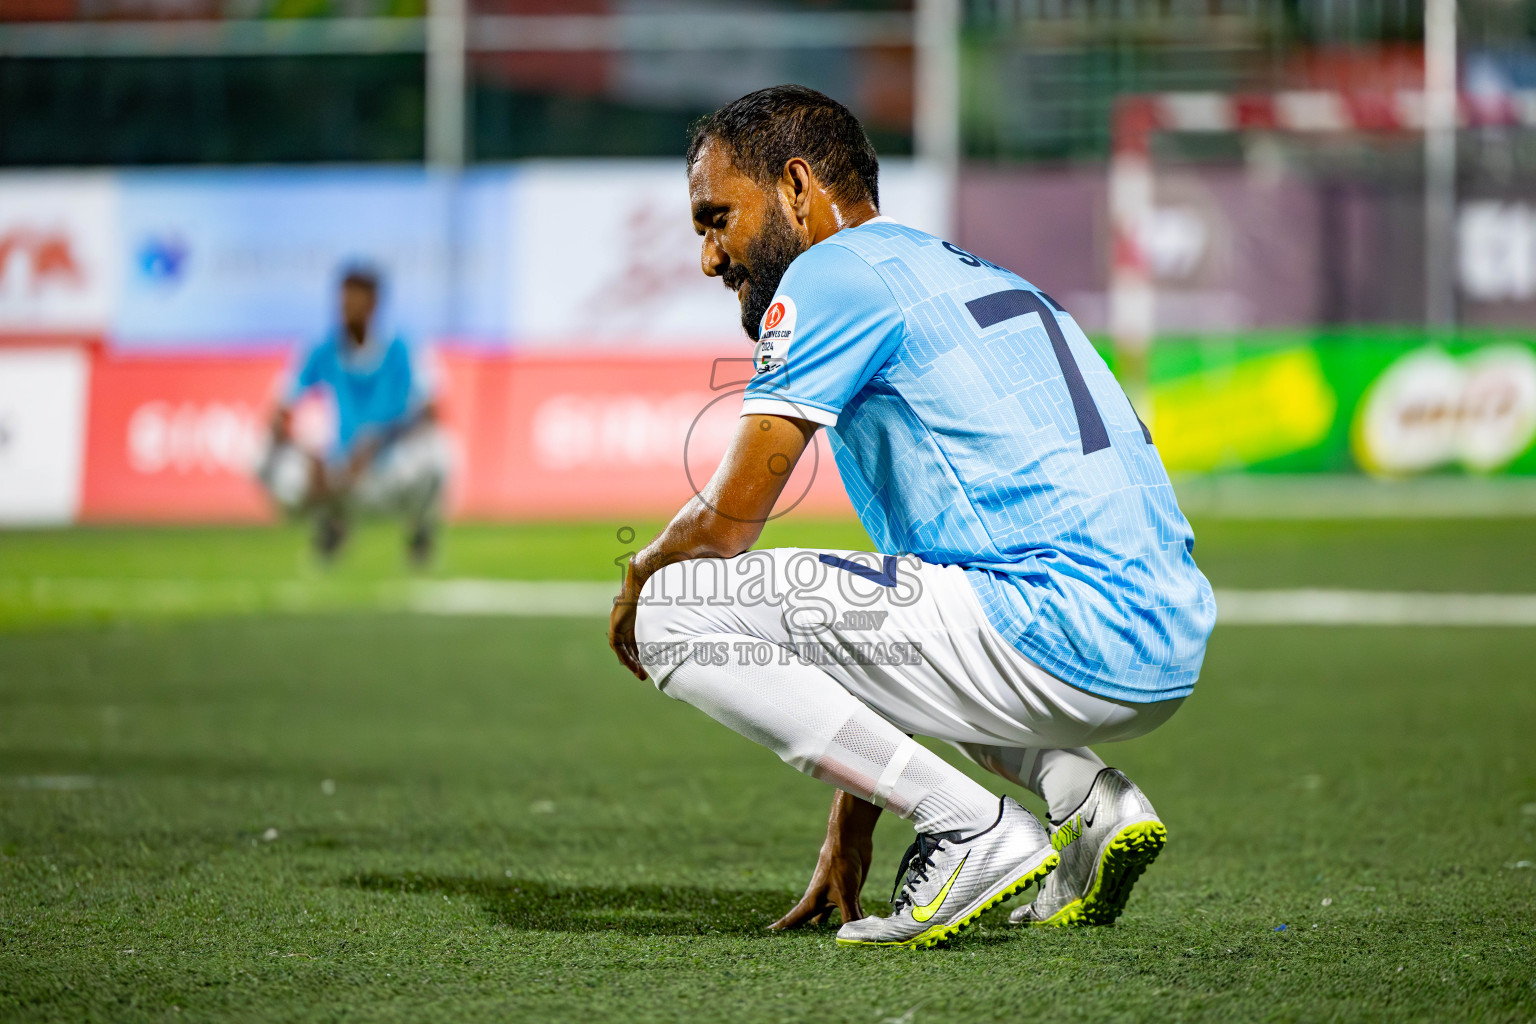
0, 330, 1536, 524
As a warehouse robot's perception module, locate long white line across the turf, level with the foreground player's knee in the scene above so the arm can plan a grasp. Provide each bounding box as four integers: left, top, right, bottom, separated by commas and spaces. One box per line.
9, 579, 1536, 626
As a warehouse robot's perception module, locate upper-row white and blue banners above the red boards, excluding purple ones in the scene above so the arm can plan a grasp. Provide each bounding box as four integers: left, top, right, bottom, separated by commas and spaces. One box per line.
0, 160, 949, 353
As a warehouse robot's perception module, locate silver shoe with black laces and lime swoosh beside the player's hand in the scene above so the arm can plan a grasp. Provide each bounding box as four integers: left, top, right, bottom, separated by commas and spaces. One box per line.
837, 797, 1061, 949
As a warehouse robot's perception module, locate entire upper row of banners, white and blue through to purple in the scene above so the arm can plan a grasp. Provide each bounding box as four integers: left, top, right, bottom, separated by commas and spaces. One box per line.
9, 160, 1536, 352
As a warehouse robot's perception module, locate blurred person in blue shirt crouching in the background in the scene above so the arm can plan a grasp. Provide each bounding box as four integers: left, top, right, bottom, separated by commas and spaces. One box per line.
257, 267, 449, 565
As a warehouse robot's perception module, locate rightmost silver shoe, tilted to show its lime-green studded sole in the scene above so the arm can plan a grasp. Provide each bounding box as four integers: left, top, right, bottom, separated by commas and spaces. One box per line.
1008, 768, 1167, 927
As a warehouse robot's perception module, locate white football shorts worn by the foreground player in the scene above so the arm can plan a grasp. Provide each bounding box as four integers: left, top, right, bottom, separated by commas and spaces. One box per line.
636, 548, 1181, 749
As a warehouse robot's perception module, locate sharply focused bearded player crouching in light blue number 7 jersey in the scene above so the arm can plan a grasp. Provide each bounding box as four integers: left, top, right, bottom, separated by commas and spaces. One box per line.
610, 86, 1215, 946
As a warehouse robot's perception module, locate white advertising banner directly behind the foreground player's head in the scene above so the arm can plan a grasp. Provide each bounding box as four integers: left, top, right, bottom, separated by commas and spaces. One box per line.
507, 160, 949, 348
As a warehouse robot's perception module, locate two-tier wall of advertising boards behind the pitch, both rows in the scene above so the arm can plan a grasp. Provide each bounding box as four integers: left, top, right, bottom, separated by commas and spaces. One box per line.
9, 161, 1536, 524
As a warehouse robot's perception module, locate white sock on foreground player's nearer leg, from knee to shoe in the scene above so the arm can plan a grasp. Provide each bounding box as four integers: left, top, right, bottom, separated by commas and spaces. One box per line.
662, 633, 998, 834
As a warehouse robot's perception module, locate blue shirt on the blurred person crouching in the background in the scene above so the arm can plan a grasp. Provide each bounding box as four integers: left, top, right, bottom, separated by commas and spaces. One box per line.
287, 330, 435, 456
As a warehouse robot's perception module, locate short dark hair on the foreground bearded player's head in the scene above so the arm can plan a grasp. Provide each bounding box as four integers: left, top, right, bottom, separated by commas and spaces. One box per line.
688, 86, 880, 206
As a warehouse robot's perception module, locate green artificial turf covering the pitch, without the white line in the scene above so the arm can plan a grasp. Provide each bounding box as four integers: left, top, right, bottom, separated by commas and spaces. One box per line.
0, 520, 1536, 1024
